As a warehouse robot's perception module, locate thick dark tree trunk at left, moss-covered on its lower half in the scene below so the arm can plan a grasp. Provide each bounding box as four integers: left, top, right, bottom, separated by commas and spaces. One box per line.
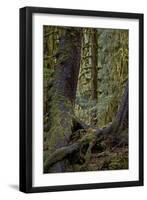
44, 28, 81, 173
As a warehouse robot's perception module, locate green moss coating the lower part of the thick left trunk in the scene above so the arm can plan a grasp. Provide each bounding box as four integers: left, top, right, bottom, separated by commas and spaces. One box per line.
48, 94, 73, 154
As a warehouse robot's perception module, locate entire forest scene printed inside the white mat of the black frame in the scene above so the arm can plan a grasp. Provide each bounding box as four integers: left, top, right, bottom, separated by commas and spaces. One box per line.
43, 26, 129, 173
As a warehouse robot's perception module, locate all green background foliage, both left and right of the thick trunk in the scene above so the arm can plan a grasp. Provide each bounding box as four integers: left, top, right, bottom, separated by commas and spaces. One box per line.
43, 26, 129, 127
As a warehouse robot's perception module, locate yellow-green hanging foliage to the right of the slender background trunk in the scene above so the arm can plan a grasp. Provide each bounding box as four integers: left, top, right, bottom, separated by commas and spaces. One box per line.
98, 29, 128, 126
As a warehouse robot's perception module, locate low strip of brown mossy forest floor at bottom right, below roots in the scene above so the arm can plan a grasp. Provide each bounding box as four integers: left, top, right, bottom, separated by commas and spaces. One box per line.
67, 147, 128, 172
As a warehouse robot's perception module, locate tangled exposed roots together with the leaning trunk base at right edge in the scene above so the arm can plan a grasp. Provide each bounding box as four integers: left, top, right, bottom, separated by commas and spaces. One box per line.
44, 82, 128, 173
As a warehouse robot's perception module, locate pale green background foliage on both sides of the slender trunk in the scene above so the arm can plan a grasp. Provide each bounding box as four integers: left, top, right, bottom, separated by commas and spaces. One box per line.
75, 28, 128, 127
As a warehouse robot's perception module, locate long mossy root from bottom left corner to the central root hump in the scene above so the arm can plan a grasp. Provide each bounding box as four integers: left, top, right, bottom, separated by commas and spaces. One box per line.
44, 124, 127, 171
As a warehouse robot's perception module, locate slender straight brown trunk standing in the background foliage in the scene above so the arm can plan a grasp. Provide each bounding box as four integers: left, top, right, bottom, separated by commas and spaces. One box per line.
91, 29, 98, 125
